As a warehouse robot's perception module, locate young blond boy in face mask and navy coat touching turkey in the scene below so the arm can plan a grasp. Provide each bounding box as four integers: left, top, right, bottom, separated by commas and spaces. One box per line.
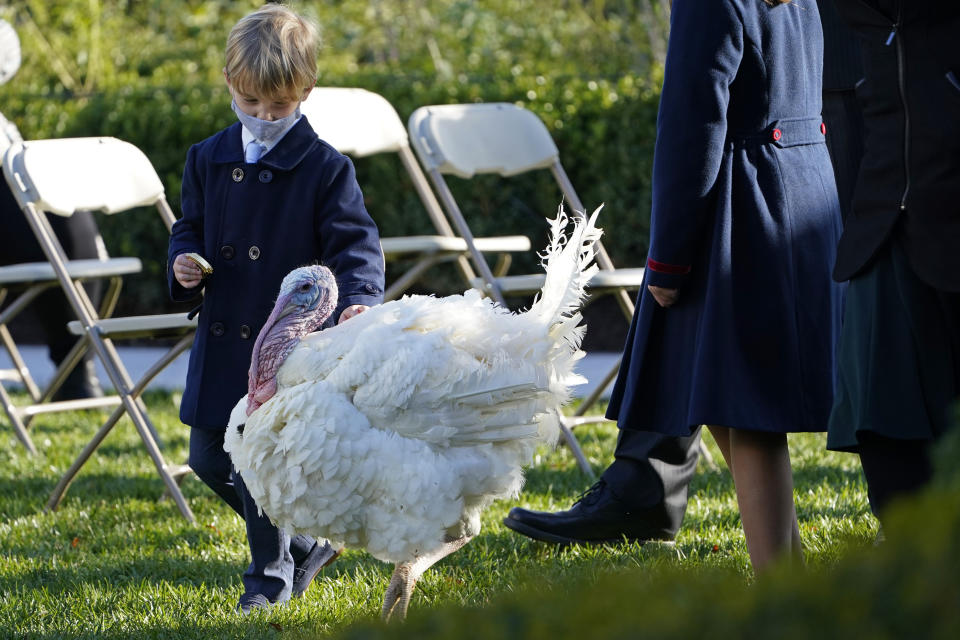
168, 4, 384, 613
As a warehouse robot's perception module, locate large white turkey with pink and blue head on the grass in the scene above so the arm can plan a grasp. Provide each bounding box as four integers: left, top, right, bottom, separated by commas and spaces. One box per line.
225, 207, 600, 619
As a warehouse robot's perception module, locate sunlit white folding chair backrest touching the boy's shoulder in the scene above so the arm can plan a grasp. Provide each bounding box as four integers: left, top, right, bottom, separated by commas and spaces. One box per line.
300, 87, 409, 158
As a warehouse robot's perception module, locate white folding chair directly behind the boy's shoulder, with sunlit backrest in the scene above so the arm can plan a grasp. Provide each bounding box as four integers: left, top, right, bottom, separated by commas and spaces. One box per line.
300, 87, 530, 300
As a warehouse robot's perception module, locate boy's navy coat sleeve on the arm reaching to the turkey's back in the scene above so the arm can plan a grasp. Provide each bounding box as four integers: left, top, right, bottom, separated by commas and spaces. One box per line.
316, 156, 384, 321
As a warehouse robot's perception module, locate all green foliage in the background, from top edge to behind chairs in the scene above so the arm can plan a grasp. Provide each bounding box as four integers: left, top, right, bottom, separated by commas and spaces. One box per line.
0, 0, 667, 311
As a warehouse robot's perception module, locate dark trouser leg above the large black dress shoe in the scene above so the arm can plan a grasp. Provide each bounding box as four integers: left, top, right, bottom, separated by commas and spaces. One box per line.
602, 428, 700, 535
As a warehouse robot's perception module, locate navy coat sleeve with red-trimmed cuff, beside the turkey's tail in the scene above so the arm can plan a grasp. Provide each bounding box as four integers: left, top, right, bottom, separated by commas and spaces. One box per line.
646, 0, 743, 288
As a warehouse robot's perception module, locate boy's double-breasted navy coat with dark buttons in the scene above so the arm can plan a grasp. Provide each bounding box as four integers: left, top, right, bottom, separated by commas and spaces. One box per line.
167, 117, 384, 429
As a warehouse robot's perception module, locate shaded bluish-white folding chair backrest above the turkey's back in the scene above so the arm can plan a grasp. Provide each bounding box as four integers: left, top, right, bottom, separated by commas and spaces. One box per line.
409, 103, 559, 178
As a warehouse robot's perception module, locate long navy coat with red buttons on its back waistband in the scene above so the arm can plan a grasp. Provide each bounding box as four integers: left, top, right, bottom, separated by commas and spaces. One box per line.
607, 0, 842, 435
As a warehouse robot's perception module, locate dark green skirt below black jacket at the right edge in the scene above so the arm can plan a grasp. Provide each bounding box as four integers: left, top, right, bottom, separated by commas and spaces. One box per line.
827, 241, 960, 451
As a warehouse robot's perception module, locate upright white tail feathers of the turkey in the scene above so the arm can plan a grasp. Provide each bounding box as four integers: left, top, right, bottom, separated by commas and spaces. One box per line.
527, 203, 603, 334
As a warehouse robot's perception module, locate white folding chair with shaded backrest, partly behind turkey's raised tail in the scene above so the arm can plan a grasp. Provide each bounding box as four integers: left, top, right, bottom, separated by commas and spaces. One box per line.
408, 103, 643, 477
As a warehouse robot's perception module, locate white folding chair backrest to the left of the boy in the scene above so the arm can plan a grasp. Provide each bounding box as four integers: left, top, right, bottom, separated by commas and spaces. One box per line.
4, 138, 163, 216
